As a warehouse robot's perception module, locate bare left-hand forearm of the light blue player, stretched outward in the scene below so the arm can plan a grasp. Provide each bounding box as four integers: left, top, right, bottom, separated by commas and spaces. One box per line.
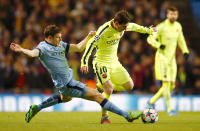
10, 43, 40, 57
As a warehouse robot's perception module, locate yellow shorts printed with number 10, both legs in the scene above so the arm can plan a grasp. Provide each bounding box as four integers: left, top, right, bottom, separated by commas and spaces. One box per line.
93, 61, 131, 88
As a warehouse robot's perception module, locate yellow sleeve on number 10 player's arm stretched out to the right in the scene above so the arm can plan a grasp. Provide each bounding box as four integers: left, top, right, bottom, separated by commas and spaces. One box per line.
126, 23, 153, 34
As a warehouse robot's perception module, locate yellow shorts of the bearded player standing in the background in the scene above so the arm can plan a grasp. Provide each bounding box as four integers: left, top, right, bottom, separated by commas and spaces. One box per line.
154, 55, 177, 82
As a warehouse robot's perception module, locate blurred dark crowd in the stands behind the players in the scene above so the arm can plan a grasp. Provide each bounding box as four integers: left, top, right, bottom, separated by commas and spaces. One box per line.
0, 0, 200, 94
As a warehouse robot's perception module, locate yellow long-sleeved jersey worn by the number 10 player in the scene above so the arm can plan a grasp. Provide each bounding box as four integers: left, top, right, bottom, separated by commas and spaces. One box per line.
81, 20, 153, 66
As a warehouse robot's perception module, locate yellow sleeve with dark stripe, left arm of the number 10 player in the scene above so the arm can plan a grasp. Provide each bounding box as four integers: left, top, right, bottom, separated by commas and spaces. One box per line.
81, 25, 109, 67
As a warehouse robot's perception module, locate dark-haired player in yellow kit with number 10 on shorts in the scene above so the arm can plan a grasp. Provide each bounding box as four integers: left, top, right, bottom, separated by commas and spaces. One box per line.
81, 10, 155, 124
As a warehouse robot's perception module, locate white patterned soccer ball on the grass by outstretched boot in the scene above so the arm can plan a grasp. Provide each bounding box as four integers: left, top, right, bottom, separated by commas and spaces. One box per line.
141, 109, 158, 123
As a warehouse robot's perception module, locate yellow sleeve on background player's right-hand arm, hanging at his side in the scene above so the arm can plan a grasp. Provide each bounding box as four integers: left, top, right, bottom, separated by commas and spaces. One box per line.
178, 25, 189, 53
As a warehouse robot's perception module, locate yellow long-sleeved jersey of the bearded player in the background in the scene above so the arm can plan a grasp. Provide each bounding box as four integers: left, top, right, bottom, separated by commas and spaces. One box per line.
147, 19, 189, 62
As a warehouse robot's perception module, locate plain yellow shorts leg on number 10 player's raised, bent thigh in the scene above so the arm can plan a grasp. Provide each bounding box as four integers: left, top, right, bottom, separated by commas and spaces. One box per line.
110, 63, 132, 86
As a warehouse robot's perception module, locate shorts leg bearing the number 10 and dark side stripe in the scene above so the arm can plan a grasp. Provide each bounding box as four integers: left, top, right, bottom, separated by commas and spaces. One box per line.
93, 62, 111, 88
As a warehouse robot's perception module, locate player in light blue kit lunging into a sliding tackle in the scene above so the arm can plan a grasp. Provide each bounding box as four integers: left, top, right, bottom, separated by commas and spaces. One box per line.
10, 25, 142, 122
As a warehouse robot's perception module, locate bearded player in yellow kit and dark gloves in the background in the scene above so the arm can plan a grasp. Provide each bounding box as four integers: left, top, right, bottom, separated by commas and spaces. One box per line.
147, 6, 189, 115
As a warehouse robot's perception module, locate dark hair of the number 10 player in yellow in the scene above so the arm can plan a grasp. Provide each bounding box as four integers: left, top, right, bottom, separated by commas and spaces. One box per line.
114, 10, 131, 25
